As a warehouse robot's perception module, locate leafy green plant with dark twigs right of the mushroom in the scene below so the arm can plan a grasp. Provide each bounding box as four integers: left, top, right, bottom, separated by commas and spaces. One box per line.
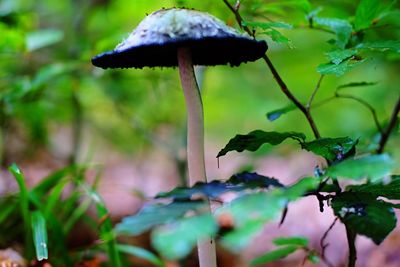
116, 0, 400, 267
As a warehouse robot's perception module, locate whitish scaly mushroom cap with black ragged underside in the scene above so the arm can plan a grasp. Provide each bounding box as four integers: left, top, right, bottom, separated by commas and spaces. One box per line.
92, 8, 267, 69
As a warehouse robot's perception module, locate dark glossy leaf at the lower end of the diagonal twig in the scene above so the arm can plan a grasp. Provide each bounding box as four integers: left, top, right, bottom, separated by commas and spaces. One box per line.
301, 137, 358, 161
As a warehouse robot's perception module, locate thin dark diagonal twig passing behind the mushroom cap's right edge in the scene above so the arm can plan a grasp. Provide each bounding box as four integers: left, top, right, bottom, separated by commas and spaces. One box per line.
223, 0, 321, 139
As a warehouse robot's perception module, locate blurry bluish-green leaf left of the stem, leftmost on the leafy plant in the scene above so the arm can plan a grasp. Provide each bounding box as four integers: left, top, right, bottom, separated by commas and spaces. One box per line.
115, 201, 204, 235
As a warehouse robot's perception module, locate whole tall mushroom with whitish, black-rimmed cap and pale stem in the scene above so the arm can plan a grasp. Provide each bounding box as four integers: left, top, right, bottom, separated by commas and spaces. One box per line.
92, 8, 267, 267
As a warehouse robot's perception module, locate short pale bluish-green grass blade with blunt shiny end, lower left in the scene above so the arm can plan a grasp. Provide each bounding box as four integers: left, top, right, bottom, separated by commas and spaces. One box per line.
31, 211, 49, 261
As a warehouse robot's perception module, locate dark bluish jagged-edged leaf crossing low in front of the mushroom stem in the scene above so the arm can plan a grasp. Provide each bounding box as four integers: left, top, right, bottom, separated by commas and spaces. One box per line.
156, 172, 283, 200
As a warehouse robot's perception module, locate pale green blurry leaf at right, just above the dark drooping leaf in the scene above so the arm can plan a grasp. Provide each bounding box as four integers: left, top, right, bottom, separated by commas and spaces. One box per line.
326, 154, 394, 182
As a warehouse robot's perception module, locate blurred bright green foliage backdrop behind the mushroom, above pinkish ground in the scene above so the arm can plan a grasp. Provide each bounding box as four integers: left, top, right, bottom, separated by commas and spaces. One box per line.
0, 0, 400, 166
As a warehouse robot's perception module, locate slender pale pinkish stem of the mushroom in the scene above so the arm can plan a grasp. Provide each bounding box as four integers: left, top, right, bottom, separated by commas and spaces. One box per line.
178, 47, 217, 267
